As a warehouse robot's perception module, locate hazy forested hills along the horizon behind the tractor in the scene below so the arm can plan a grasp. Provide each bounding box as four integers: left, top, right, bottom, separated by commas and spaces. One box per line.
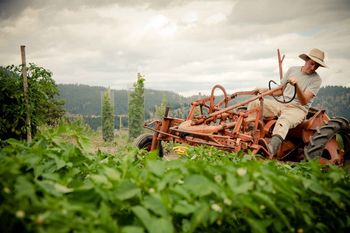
58, 84, 350, 128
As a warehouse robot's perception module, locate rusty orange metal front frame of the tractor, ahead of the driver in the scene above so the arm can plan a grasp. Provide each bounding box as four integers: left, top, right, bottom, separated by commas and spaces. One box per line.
144, 85, 283, 155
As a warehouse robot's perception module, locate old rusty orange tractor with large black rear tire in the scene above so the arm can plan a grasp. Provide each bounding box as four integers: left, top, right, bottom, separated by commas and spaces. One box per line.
135, 50, 350, 166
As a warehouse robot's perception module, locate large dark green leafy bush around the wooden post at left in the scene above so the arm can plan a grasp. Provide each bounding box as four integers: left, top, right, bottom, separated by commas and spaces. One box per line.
0, 64, 64, 140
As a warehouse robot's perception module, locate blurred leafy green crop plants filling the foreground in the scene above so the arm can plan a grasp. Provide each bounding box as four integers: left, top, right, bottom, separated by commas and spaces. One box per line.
0, 125, 350, 233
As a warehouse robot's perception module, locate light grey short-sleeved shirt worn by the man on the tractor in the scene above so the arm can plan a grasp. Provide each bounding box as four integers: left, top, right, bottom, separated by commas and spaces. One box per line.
281, 66, 322, 108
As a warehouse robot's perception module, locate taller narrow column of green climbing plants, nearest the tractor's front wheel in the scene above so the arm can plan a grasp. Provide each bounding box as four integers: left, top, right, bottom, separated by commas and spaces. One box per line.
128, 74, 145, 139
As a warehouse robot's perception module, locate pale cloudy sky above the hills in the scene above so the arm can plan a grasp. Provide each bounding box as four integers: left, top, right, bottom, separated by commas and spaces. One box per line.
0, 0, 350, 96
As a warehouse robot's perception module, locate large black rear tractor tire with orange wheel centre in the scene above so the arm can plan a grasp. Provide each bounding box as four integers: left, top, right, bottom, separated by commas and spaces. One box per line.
304, 117, 350, 166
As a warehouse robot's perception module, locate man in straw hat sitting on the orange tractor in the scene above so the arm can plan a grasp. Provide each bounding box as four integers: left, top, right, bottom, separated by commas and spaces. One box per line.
247, 49, 327, 156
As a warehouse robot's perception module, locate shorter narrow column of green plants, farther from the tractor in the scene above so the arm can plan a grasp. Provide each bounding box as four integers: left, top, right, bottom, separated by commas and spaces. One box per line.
102, 89, 114, 142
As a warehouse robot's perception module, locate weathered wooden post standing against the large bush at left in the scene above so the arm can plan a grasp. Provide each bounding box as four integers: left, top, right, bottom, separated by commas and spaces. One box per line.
21, 45, 32, 143
